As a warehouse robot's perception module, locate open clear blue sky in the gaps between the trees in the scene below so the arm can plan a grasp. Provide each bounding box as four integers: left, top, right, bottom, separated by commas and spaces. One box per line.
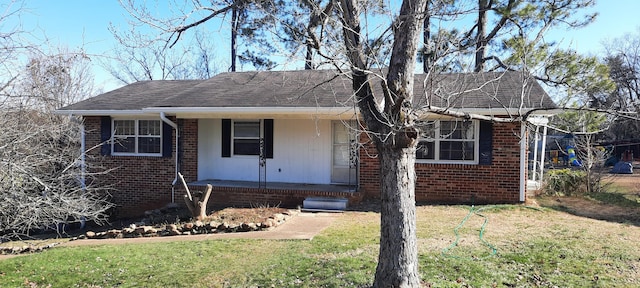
15, 0, 640, 91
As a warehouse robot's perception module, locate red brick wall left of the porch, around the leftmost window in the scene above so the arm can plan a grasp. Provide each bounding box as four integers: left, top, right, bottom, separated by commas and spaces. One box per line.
84, 117, 198, 217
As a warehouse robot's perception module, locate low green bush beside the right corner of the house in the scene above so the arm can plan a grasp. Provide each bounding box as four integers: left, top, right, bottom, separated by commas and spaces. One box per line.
544, 168, 587, 196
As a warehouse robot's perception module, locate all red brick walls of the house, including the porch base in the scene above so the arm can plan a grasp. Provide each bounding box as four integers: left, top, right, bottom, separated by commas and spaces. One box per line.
85, 117, 520, 217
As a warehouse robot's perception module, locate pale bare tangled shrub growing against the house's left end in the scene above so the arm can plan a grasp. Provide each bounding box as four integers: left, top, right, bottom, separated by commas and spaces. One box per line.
0, 107, 112, 239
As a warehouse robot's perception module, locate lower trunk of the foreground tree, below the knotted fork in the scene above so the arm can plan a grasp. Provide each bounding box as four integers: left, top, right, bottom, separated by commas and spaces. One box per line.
374, 141, 420, 287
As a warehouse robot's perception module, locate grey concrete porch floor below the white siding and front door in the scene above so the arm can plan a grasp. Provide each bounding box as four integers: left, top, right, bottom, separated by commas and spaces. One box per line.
187, 179, 358, 193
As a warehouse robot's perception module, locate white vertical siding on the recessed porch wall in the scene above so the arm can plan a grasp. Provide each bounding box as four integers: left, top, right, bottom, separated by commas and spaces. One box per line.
198, 119, 331, 184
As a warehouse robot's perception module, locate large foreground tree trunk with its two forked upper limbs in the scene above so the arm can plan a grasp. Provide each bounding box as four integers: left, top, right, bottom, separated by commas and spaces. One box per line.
340, 0, 426, 288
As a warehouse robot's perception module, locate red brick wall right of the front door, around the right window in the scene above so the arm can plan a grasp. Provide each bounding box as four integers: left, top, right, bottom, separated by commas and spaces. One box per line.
360, 123, 526, 204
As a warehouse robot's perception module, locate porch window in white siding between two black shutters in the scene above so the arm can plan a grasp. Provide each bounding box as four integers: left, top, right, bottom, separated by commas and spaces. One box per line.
233, 120, 261, 155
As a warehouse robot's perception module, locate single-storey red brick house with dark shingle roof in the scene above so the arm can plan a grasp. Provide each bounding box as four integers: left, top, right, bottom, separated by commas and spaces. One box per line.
57, 70, 555, 217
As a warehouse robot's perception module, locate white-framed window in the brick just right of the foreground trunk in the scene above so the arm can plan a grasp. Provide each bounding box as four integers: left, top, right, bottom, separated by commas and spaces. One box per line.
416, 121, 479, 163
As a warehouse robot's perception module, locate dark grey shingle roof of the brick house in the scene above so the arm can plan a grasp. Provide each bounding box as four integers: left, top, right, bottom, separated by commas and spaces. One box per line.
61, 70, 555, 110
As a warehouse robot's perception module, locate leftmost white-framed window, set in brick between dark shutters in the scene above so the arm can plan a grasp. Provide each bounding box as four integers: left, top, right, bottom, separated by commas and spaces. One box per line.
111, 120, 162, 156
